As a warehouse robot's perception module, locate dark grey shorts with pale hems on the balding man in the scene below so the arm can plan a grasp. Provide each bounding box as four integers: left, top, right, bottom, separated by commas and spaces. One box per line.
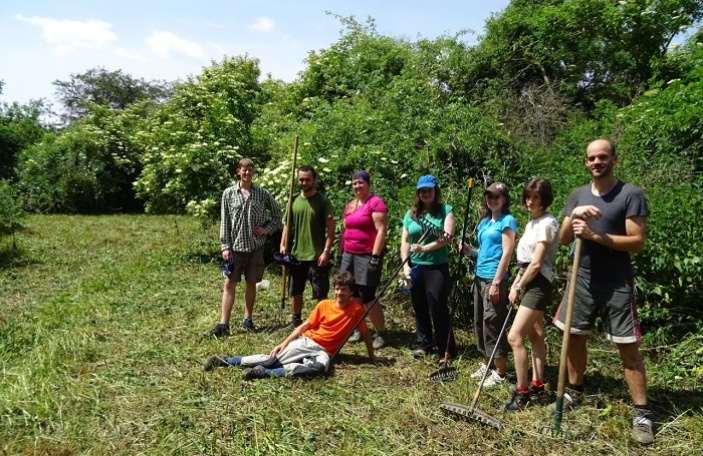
554, 273, 642, 344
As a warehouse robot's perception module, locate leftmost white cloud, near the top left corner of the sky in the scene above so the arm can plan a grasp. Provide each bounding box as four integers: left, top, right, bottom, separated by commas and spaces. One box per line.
14, 14, 117, 55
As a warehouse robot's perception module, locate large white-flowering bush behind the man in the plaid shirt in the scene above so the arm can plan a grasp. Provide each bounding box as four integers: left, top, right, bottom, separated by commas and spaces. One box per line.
136, 56, 269, 218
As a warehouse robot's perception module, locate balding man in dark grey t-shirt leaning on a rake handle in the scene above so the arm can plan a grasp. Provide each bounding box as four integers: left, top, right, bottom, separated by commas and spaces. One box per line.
554, 139, 654, 445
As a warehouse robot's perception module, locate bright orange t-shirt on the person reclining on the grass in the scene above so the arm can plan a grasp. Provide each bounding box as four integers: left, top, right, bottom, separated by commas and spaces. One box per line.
305, 299, 366, 355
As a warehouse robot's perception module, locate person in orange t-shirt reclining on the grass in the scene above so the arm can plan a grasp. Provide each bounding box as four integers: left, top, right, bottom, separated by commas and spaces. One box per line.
204, 272, 384, 380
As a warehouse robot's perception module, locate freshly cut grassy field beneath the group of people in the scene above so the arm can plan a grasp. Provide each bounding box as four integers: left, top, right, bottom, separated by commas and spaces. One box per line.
0, 216, 703, 455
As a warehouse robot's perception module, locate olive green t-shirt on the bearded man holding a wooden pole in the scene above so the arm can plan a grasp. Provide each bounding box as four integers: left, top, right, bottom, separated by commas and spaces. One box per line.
291, 192, 333, 261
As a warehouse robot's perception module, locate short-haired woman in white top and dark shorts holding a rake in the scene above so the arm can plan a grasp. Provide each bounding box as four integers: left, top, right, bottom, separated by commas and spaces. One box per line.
505, 178, 559, 411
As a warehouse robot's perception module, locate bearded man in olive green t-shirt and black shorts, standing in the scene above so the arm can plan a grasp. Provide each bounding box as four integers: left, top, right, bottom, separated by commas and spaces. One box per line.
280, 165, 334, 329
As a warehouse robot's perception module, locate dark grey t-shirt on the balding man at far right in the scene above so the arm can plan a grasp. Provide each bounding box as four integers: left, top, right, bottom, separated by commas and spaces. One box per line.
562, 181, 649, 281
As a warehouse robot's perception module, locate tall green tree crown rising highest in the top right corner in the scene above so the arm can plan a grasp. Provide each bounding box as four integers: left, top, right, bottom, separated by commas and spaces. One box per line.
462, 0, 703, 110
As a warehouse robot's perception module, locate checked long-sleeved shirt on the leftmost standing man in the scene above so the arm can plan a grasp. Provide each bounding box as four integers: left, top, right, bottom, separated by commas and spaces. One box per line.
220, 184, 282, 252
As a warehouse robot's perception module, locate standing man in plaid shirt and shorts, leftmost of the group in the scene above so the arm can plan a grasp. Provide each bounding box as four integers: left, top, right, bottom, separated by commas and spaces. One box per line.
205, 158, 282, 337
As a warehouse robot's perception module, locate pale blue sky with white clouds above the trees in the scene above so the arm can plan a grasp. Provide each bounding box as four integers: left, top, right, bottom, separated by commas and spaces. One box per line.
0, 0, 509, 103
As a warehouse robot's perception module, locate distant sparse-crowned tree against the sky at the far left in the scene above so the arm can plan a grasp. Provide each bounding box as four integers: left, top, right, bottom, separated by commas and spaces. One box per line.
52, 67, 172, 124
